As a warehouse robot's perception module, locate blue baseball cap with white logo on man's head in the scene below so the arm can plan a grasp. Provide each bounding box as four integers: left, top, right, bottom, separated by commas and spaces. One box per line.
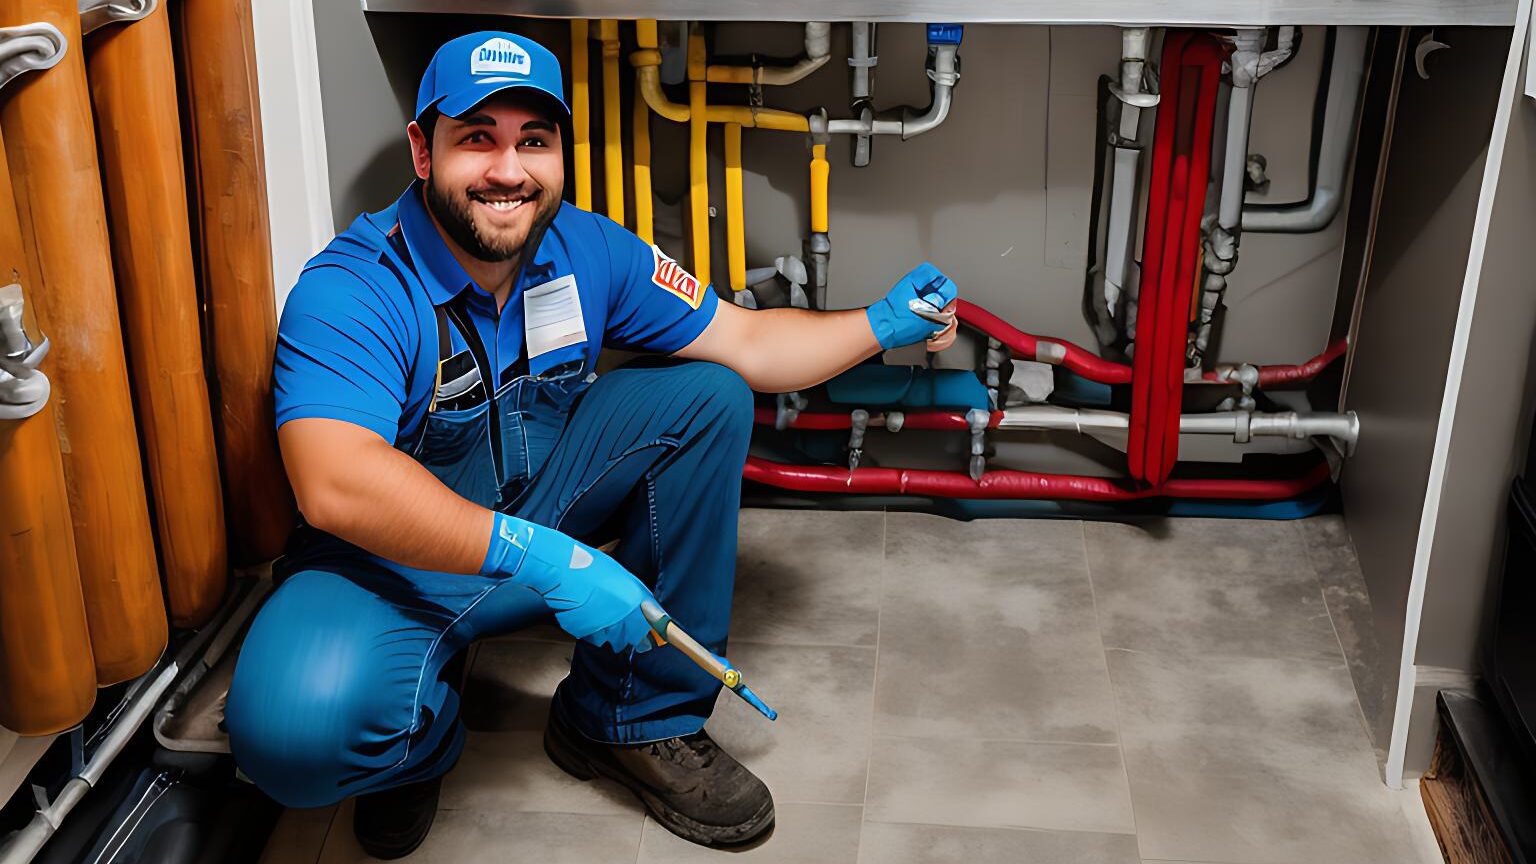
416, 31, 571, 123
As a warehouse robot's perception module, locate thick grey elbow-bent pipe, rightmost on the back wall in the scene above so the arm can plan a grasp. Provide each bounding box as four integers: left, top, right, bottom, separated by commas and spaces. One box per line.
1243, 28, 1370, 234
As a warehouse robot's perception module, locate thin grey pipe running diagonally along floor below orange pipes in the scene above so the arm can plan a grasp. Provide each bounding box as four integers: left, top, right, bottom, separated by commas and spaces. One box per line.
0, 580, 272, 864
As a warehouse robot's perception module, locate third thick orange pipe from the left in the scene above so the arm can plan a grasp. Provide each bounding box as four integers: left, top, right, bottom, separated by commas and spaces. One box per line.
86, 3, 229, 627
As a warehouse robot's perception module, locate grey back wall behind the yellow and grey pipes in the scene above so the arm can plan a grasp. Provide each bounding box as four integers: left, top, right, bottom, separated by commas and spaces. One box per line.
315, 10, 1342, 363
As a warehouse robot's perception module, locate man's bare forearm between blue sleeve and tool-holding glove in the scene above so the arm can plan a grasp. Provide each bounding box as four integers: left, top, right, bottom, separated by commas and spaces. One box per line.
278, 418, 492, 573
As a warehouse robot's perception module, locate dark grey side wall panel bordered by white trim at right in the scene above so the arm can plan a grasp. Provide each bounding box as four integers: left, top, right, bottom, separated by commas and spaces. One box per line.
1342, 28, 1505, 769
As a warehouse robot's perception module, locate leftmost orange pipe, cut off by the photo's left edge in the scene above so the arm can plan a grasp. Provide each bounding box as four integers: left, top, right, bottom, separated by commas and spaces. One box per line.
0, 124, 97, 735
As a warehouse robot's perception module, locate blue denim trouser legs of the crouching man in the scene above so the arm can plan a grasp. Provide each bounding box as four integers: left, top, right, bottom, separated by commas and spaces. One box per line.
226, 358, 753, 807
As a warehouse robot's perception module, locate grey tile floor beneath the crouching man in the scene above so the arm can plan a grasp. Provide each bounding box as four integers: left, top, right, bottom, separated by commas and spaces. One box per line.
264, 510, 1439, 864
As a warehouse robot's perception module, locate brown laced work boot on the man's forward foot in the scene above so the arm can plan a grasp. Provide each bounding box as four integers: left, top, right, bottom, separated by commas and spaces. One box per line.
544, 706, 774, 846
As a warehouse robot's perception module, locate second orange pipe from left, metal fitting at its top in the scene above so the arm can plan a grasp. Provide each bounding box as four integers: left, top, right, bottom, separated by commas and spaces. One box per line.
0, 0, 166, 684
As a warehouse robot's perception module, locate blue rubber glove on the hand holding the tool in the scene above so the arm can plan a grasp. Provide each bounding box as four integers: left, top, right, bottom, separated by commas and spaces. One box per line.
481, 512, 656, 652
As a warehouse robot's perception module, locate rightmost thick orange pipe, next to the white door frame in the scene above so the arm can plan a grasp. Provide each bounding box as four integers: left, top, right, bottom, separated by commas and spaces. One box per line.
180, 0, 296, 564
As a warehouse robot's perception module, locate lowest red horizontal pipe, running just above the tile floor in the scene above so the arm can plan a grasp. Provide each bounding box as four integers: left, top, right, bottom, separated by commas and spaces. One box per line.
742, 457, 1329, 501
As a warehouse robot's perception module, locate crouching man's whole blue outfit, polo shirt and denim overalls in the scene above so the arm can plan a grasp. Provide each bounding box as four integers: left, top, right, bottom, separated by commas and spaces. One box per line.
226, 186, 753, 807
